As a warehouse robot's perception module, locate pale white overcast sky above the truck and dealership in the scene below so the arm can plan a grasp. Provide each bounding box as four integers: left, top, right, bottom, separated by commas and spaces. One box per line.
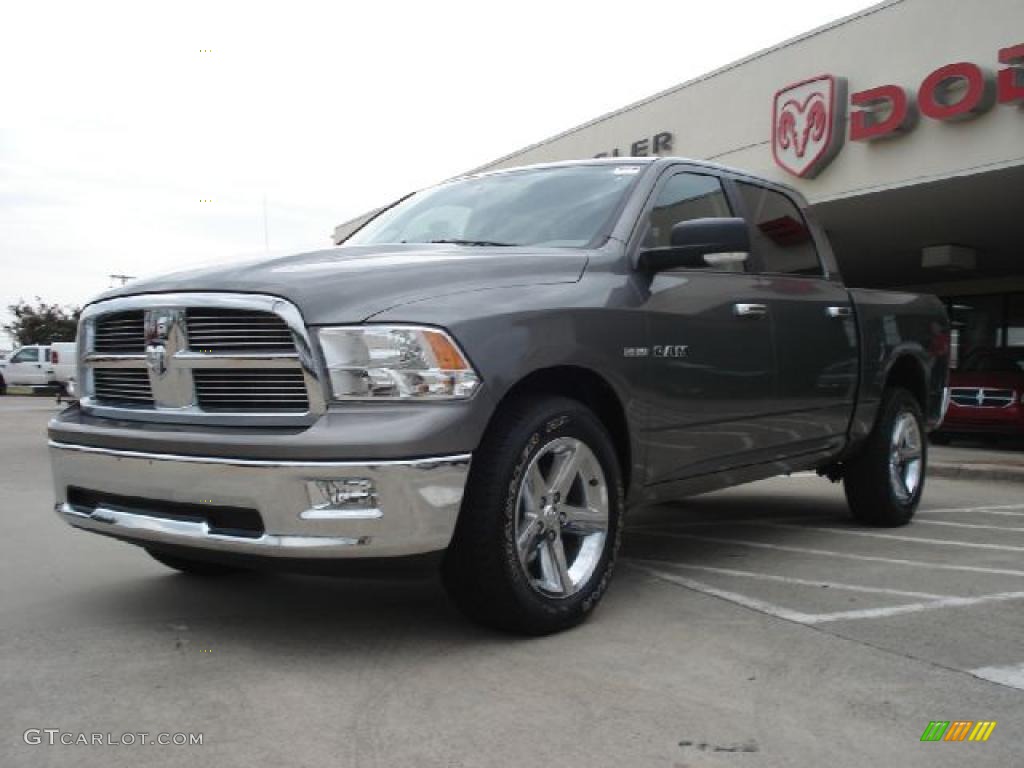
0, 0, 872, 348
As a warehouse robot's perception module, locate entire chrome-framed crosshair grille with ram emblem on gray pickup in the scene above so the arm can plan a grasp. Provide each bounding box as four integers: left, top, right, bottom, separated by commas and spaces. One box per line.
79, 293, 327, 425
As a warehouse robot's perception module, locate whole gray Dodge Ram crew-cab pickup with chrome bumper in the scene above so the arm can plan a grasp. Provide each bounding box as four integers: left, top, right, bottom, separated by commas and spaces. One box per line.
49, 158, 949, 634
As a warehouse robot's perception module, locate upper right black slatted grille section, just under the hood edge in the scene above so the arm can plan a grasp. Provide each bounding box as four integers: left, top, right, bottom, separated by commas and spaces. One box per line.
185, 307, 295, 352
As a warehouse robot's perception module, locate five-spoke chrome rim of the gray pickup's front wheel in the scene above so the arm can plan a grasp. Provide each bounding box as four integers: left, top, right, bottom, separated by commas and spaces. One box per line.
515, 437, 608, 598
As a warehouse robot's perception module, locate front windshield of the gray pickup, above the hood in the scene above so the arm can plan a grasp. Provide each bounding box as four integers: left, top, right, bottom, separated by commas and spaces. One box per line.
345, 165, 641, 248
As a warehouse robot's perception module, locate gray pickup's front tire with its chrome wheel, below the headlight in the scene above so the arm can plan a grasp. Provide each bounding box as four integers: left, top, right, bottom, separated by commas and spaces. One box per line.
442, 396, 625, 635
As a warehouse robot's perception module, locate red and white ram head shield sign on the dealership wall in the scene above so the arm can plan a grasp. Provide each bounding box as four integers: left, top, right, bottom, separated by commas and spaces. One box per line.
772, 75, 846, 178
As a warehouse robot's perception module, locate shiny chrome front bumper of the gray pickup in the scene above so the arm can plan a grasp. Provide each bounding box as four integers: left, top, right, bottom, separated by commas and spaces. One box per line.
49, 440, 470, 558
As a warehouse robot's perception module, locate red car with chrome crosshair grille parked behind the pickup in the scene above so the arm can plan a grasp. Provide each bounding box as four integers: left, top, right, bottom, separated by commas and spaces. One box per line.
932, 347, 1024, 442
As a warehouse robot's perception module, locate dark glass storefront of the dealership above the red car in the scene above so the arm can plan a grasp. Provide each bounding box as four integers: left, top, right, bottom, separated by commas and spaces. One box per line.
943, 293, 1024, 368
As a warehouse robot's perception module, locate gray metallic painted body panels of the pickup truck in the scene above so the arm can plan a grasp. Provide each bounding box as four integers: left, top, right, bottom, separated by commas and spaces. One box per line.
50, 159, 948, 507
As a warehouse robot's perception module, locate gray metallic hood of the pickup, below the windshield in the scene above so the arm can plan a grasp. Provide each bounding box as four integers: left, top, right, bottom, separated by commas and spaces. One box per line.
96, 243, 588, 326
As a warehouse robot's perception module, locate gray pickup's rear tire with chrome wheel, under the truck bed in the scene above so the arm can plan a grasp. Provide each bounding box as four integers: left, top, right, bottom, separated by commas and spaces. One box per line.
843, 387, 928, 527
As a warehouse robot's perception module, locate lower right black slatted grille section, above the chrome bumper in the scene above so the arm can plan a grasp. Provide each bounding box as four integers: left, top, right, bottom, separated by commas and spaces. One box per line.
193, 368, 309, 413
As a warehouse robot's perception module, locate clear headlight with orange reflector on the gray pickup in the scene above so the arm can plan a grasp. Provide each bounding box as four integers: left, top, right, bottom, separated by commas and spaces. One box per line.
318, 326, 480, 400
